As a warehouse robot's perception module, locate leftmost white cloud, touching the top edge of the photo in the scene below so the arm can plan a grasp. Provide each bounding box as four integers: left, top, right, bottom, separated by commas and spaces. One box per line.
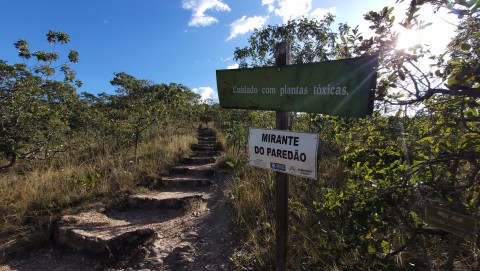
182, 0, 230, 27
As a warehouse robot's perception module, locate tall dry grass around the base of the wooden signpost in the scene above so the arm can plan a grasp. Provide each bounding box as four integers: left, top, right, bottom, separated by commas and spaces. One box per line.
224, 147, 352, 270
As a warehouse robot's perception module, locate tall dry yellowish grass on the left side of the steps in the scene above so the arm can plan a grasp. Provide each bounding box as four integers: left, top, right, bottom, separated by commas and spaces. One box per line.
0, 122, 196, 260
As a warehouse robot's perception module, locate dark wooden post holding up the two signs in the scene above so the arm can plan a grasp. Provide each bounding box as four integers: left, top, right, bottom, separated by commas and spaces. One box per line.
275, 42, 292, 271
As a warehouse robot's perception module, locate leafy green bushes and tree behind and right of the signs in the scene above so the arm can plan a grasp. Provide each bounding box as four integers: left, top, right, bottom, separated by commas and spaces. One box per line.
223, 0, 480, 270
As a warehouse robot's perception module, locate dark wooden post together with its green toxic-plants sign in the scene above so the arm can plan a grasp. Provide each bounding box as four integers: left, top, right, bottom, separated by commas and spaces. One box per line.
216, 42, 378, 271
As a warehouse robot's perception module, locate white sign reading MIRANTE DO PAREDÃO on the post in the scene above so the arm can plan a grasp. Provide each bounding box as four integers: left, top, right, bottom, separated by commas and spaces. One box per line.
248, 128, 318, 179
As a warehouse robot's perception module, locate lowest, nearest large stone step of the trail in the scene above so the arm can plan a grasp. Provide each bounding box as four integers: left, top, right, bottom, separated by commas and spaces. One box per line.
53, 211, 155, 262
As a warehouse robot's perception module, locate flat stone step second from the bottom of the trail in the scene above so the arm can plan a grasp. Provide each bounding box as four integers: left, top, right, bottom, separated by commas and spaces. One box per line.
128, 191, 205, 211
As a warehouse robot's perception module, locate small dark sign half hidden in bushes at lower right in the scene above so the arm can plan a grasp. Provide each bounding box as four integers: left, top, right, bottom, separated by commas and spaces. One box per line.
425, 205, 477, 242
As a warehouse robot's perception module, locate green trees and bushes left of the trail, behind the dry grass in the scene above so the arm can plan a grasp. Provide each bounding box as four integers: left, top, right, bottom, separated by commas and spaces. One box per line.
0, 30, 202, 169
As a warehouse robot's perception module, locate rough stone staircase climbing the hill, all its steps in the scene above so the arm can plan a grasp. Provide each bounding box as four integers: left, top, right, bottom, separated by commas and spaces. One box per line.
54, 129, 220, 270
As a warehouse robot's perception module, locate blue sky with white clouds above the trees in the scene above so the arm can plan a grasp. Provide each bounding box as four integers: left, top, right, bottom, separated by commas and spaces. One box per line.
0, 0, 456, 100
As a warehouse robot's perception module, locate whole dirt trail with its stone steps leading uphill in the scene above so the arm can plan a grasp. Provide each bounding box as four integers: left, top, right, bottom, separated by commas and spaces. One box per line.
0, 129, 236, 271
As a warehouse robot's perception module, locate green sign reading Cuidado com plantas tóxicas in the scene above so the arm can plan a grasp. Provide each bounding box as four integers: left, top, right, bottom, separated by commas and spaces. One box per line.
217, 56, 378, 117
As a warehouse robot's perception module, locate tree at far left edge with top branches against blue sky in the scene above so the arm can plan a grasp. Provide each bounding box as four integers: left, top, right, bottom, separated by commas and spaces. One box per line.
0, 30, 81, 168
